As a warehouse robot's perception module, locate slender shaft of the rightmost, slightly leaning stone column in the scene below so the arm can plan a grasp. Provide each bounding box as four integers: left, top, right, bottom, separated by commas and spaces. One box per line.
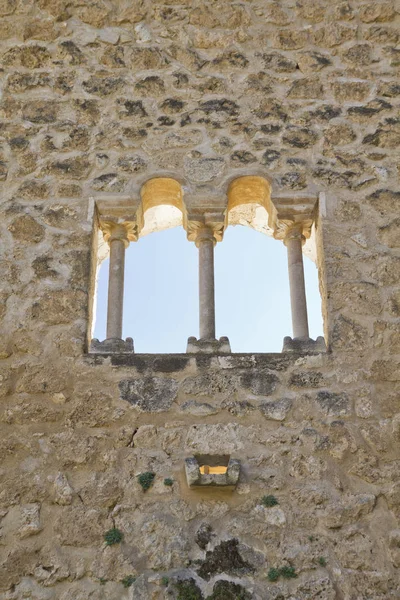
285, 231, 309, 338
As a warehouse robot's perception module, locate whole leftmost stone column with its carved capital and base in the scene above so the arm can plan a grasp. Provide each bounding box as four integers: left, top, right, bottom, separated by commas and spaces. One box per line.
90, 221, 137, 354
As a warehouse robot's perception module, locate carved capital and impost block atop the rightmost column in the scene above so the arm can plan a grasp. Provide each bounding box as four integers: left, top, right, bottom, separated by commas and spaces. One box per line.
268, 196, 318, 241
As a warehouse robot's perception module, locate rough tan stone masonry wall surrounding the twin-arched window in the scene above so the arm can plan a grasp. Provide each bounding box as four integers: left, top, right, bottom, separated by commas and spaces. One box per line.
0, 0, 400, 600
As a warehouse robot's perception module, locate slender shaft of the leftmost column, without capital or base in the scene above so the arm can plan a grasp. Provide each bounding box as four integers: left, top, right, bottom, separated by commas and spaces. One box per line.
107, 238, 125, 339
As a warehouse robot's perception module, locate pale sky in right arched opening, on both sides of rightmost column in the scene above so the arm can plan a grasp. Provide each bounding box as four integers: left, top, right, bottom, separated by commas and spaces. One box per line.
215, 226, 323, 352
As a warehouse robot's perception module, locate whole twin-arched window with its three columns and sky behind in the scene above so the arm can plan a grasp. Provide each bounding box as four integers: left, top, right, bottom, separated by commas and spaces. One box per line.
91, 176, 326, 354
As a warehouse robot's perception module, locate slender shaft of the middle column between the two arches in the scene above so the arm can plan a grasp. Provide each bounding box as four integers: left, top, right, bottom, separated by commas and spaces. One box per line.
196, 228, 215, 340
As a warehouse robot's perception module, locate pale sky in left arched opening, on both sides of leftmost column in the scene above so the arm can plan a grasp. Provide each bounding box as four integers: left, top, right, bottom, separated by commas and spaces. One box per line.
94, 227, 198, 354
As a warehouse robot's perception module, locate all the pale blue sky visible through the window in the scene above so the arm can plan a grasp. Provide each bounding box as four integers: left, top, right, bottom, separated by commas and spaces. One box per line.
94, 225, 323, 353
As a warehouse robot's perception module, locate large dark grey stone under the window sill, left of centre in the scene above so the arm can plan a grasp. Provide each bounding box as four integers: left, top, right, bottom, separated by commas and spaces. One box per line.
119, 377, 178, 412
